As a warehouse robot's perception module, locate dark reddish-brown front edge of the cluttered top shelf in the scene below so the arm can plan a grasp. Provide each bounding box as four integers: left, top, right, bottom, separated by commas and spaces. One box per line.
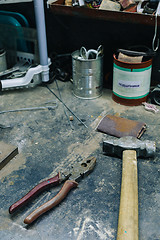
50, 0, 160, 26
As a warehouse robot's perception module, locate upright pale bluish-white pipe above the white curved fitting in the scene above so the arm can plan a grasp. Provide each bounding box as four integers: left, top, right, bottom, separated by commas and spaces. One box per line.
34, 0, 49, 82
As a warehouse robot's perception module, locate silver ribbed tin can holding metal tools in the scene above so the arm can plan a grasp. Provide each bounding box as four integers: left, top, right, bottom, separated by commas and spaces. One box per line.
72, 50, 103, 99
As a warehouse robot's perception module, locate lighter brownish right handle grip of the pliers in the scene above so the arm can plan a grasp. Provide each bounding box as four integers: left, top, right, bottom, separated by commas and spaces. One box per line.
24, 180, 78, 224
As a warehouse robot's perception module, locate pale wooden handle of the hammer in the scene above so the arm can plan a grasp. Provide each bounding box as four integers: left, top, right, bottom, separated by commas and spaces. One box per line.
117, 150, 138, 240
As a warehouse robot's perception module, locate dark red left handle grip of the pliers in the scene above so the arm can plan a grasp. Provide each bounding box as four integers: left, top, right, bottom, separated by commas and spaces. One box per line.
9, 173, 60, 213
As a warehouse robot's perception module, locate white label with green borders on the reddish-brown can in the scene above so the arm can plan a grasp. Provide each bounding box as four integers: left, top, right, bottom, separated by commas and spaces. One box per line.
113, 65, 151, 99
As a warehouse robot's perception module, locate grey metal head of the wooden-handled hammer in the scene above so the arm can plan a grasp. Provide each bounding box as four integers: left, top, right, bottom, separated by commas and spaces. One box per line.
103, 136, 156, 158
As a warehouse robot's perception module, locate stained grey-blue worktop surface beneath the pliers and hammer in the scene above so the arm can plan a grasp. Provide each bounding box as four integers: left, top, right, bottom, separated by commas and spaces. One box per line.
0, 81, 160, 240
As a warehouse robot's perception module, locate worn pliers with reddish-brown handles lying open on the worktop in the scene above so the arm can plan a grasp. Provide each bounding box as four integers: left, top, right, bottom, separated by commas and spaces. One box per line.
9, 157, 96, 224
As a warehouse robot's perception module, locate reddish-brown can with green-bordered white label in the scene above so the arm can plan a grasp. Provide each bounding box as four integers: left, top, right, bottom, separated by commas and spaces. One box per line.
112, 54, 152, 106
